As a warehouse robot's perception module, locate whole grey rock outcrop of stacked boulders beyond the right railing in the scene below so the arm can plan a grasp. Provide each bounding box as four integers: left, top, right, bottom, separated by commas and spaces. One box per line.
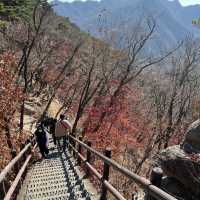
153, 119, 200, 200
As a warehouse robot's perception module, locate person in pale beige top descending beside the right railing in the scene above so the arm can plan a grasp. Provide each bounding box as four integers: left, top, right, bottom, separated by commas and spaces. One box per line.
55, 114, 72, 151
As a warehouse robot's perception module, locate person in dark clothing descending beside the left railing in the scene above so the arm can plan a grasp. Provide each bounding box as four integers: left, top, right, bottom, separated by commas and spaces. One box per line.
35, 122, 49, 158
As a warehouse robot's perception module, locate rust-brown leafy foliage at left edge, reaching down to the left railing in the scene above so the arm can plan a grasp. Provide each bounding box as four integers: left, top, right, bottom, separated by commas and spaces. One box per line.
0, 53, 23, 168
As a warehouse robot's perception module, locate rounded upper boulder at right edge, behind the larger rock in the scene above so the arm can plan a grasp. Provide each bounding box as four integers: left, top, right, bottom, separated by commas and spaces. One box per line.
184, 119, 200, 152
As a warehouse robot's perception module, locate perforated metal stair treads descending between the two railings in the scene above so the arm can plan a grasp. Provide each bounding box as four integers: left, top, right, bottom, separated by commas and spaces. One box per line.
17, 139, 91, 200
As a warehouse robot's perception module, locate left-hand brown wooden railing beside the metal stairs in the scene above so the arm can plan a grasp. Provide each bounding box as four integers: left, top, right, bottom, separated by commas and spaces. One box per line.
0, 137, 37, 200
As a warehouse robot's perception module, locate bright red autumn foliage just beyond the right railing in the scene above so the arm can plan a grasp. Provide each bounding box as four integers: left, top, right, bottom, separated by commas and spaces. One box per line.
83, 81, 150, 186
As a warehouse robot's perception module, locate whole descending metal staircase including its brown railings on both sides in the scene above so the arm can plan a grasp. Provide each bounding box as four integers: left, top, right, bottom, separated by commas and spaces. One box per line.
0, 131, 177, 200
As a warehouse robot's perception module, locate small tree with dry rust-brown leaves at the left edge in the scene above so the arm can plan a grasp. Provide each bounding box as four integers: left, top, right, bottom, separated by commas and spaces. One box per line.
0, 52, 24, 159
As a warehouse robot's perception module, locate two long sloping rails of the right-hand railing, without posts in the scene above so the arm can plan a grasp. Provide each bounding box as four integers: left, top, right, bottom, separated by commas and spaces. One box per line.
68, 135, 177, 200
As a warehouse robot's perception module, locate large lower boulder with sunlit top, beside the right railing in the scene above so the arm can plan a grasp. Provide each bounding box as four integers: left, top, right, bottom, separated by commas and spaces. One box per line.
156, 145, 200, 199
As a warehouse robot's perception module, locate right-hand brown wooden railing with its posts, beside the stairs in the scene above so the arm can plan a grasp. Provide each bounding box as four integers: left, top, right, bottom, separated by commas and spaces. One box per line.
68, 135, 177, 200
